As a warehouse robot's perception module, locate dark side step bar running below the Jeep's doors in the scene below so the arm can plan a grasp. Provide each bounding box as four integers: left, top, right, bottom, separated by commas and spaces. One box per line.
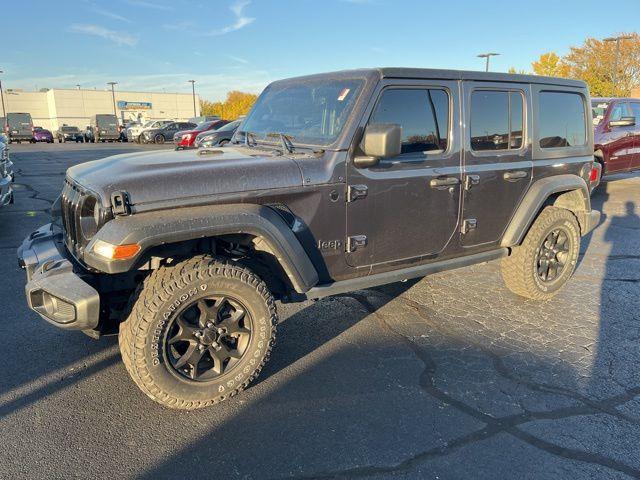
305, 248, 509, 299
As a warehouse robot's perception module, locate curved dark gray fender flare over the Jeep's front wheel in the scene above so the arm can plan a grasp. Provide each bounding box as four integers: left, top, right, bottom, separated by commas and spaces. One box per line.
83, 204, 319, 293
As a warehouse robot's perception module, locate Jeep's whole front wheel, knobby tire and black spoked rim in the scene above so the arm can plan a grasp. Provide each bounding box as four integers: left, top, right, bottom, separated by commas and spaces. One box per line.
119, 255, 277, 410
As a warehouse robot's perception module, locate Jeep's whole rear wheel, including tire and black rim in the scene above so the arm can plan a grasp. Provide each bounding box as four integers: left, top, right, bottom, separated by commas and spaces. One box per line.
502, 207, 580, 300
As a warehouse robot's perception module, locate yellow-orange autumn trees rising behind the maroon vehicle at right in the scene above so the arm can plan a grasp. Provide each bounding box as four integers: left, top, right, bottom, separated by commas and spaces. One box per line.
531, 33, 640, 97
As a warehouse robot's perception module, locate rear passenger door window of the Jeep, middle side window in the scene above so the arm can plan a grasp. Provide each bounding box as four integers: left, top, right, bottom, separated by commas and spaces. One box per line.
470, 90, 524, 151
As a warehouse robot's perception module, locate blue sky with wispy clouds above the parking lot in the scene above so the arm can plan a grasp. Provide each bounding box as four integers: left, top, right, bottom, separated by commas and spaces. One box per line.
0, 0, 640, 100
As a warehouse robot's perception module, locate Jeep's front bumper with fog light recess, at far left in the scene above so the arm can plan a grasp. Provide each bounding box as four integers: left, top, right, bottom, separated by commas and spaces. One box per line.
18, 224, 100, 330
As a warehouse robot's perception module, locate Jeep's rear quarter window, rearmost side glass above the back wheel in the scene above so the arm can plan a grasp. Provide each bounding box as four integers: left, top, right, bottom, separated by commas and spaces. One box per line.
538, 91, 587, 149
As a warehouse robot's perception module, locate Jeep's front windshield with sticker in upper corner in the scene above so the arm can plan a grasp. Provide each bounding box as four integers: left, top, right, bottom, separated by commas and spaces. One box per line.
239, 77, 364, 146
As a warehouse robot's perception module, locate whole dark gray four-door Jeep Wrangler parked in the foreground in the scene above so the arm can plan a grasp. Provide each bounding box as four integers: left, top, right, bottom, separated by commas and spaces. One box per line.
18, 68, 600, 409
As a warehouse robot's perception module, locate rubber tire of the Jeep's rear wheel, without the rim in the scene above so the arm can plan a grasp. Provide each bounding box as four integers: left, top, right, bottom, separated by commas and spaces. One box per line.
501, 207, 580, 300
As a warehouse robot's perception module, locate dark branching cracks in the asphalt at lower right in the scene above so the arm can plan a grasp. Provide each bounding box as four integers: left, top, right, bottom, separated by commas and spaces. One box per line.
276, 291, 640, 479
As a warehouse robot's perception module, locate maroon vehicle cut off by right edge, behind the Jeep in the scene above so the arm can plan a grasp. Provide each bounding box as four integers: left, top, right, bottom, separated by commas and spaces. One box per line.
591, 98, 640, 180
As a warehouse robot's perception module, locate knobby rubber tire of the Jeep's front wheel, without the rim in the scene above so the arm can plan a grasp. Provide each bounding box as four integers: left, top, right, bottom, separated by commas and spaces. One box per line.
118, 255, 277, 410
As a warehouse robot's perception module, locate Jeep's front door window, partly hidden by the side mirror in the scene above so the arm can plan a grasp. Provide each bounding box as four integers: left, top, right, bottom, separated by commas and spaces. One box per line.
369, 88, 449, 154
